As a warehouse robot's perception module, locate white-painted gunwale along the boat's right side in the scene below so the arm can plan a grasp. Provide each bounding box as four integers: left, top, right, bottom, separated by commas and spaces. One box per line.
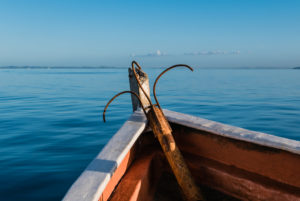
163, 109, 300, 154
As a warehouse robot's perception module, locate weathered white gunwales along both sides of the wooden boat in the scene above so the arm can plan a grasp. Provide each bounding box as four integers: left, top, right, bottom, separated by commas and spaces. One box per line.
63, 110, 300, 201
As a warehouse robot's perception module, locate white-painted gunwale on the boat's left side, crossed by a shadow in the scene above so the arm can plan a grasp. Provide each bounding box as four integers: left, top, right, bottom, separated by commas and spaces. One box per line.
63, 111, 147, 201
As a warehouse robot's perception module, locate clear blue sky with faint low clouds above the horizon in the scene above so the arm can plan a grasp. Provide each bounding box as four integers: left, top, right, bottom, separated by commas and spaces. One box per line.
0, 0, 300, 67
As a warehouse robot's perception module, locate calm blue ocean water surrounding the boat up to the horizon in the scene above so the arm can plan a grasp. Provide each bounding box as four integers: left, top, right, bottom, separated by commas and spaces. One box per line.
0, 68, 300, 201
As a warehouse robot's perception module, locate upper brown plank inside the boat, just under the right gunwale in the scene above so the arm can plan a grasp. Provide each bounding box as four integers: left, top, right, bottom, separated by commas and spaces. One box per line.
174, 124, 300, 188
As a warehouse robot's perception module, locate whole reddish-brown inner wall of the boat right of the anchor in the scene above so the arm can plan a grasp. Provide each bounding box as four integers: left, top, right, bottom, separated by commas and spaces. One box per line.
172, 125, 300, 201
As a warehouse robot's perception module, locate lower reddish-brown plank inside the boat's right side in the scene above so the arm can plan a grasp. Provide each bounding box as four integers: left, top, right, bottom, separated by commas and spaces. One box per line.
187, 156, 300, 201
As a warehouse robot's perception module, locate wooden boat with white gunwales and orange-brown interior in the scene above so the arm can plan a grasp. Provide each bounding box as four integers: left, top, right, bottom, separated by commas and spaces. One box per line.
63, 64, 300, 201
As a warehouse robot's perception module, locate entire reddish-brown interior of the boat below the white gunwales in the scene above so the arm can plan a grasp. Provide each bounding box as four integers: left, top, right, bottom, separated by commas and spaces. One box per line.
100, 124, 299, 201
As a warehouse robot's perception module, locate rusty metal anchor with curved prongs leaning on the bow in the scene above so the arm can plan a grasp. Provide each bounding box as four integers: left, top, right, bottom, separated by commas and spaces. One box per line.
103, 61, 205, 201
